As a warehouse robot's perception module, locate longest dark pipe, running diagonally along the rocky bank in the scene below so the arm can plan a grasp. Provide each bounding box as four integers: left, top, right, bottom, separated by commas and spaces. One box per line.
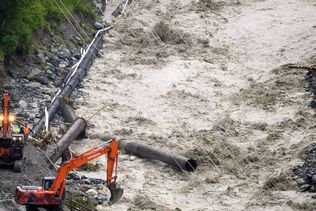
30, 31, 105, 137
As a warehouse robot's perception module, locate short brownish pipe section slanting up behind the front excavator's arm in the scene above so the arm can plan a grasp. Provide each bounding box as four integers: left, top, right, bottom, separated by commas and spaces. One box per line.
50, 118, 87, 166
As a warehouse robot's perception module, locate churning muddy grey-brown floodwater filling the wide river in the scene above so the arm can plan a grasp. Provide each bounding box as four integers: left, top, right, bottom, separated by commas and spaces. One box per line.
69, 0, 316, 210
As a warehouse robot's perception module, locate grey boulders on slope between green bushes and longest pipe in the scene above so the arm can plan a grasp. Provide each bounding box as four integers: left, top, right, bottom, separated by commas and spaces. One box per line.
4, 42, 86, 124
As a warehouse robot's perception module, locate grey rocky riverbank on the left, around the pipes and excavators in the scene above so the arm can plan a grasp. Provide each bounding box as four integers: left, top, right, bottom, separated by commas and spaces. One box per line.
0, 0, 116, 210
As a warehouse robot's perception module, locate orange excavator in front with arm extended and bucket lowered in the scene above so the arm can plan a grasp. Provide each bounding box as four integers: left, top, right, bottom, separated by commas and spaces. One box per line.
15, 139, 123, 211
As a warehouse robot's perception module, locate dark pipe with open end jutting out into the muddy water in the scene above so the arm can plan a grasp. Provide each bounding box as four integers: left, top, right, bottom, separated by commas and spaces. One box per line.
100, 136, 197, 172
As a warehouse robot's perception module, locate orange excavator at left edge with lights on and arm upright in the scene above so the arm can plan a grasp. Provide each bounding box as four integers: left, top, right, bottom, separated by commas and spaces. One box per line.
0, 90, 25, 172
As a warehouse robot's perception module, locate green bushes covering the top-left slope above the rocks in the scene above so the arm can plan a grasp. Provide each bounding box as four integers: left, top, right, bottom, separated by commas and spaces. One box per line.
0, 0, 94, 58
